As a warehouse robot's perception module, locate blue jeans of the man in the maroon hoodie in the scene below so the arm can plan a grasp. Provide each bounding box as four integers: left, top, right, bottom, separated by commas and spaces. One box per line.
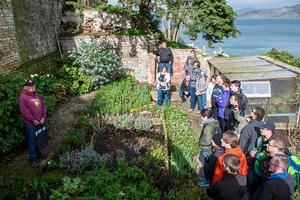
26, 125, 41, 162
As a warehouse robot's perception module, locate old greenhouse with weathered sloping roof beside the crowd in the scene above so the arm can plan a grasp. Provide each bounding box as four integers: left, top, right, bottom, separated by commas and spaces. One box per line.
208, 56, 300, 129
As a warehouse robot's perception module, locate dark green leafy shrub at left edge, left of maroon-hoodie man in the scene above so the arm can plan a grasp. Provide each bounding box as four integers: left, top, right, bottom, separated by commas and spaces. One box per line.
0, 74, 26, 156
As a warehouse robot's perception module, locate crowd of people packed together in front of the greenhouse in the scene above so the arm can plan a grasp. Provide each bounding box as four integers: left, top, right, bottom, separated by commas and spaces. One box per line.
193, 74, 296, 200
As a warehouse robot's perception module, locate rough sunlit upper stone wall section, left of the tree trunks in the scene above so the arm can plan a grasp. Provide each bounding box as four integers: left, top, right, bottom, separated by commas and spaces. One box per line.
62, 10, 135, 34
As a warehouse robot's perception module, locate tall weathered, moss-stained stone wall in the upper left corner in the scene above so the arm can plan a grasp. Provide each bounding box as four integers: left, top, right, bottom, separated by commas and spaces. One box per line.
0, 0, 62, 73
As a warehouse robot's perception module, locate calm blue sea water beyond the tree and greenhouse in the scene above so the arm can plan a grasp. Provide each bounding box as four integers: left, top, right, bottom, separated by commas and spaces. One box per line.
181, 19, 300, 57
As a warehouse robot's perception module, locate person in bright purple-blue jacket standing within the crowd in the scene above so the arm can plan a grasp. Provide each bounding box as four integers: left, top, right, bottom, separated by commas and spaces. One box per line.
216, 82, 230, 133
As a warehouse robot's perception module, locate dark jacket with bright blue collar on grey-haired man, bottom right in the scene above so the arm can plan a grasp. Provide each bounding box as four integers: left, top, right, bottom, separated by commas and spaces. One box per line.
251, 172, 295, 200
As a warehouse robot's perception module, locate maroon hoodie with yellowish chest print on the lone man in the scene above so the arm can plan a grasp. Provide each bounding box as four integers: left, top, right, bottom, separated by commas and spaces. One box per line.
19, 90, 46, 125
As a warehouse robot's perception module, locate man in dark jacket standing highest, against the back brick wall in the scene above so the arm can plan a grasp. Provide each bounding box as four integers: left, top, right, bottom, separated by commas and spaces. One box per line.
152, 41, 174, 76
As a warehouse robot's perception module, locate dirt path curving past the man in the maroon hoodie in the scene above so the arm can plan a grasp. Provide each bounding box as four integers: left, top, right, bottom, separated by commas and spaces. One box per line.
3, 92, 96, 169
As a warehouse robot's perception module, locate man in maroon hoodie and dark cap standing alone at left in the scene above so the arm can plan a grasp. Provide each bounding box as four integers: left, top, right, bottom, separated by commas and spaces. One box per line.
19, 80, 46, 168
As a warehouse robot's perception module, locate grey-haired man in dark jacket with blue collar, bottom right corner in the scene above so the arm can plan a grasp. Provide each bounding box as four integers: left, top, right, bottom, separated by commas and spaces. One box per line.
250, 154, 295, 200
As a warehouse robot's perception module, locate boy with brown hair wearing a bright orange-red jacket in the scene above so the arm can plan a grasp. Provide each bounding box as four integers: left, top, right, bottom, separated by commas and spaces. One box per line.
212, 131, 247, 185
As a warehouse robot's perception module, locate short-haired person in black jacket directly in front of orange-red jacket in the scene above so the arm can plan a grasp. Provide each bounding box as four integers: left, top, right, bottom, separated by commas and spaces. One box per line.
207, 154, 247, 200
